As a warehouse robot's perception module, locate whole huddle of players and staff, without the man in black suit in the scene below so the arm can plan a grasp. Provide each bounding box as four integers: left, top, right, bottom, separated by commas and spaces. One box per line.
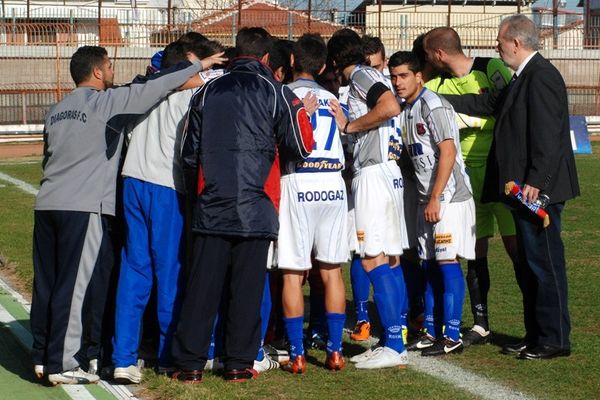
31, 14, 568, 384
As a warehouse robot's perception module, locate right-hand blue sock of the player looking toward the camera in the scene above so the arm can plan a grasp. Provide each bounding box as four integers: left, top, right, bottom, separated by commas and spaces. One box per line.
440, 262, 465, 342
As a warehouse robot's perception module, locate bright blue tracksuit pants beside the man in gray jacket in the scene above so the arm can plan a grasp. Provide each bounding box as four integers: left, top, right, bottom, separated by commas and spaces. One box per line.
113, 178, 184, 367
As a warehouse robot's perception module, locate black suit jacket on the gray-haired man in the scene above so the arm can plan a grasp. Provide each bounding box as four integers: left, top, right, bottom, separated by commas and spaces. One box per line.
446, 53, 579, 203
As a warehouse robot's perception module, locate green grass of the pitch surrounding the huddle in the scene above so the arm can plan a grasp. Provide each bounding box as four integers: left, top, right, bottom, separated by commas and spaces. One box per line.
0, 143, 600, 400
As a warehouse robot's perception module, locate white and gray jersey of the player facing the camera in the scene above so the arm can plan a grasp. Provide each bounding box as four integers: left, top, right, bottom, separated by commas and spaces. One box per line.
400, 88, 472, 203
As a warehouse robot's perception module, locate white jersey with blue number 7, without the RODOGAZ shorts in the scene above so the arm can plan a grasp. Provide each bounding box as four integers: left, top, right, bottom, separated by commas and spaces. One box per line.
283, 79, 344, 174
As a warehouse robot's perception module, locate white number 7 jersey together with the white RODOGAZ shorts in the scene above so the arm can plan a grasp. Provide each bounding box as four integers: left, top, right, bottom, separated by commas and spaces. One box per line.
278, 79, 350, 271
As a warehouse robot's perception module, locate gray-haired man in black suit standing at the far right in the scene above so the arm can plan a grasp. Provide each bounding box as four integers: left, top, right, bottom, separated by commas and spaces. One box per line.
446, 15, 579, 359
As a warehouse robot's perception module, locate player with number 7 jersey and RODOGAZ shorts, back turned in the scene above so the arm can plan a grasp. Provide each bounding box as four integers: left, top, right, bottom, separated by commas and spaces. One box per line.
278, 34, 349, 373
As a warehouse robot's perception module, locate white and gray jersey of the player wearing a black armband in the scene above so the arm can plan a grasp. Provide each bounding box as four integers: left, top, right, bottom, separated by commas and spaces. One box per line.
348, 65, 402, 173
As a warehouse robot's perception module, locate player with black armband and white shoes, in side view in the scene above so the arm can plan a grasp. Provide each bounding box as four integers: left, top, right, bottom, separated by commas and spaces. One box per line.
327, 29, 408, 369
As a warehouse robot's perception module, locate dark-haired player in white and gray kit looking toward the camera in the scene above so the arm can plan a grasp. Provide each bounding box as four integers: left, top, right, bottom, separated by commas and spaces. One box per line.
393, 52, 475, 356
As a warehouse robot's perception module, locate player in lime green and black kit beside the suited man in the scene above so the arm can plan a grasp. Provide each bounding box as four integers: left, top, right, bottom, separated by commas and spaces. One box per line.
423, 27, 518, 346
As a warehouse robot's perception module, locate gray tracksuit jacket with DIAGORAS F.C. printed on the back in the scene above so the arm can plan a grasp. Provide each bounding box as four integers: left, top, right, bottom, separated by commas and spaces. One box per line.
35, 62, 202, 215
